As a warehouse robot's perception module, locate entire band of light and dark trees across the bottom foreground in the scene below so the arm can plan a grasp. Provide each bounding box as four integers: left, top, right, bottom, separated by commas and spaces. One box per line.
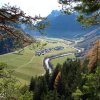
0, 55, 100, 100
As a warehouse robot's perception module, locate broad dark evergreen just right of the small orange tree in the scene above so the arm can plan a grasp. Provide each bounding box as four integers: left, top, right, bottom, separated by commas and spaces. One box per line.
61, 61, 81, 99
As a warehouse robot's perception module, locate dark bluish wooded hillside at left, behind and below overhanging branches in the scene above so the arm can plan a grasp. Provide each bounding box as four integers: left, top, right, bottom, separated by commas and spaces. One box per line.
0, 28, 33, 54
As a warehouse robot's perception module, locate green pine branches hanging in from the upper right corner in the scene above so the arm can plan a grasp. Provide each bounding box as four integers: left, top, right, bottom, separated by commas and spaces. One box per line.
59, 0, 100, 26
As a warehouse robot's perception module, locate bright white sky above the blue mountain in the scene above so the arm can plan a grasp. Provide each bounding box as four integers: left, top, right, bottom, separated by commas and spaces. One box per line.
0, 0, 61, 17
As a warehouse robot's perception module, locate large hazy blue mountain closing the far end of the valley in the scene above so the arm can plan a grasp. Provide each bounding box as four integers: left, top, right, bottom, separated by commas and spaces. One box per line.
30, 10, 98, 38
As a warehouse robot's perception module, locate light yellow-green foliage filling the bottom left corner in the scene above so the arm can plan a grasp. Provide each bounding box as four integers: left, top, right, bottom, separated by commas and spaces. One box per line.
0, 63, 32, 100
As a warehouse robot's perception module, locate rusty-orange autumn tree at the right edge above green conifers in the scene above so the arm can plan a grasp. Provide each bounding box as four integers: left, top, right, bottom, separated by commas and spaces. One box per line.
87, 40, 100, 72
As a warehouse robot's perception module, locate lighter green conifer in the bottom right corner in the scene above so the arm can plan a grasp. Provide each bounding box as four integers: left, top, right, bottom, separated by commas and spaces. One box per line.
79, 66, 100, 100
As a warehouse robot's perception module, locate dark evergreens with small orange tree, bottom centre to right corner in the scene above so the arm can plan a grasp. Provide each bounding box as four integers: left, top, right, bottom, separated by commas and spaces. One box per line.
29, 57, 100, 100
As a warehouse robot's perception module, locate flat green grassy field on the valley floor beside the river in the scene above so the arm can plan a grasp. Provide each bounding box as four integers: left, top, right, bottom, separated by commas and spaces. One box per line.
0, 40, 74, 84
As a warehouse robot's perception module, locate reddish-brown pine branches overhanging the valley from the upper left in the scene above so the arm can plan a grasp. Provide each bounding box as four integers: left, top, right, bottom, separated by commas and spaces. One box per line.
0, 4, 47, 53
